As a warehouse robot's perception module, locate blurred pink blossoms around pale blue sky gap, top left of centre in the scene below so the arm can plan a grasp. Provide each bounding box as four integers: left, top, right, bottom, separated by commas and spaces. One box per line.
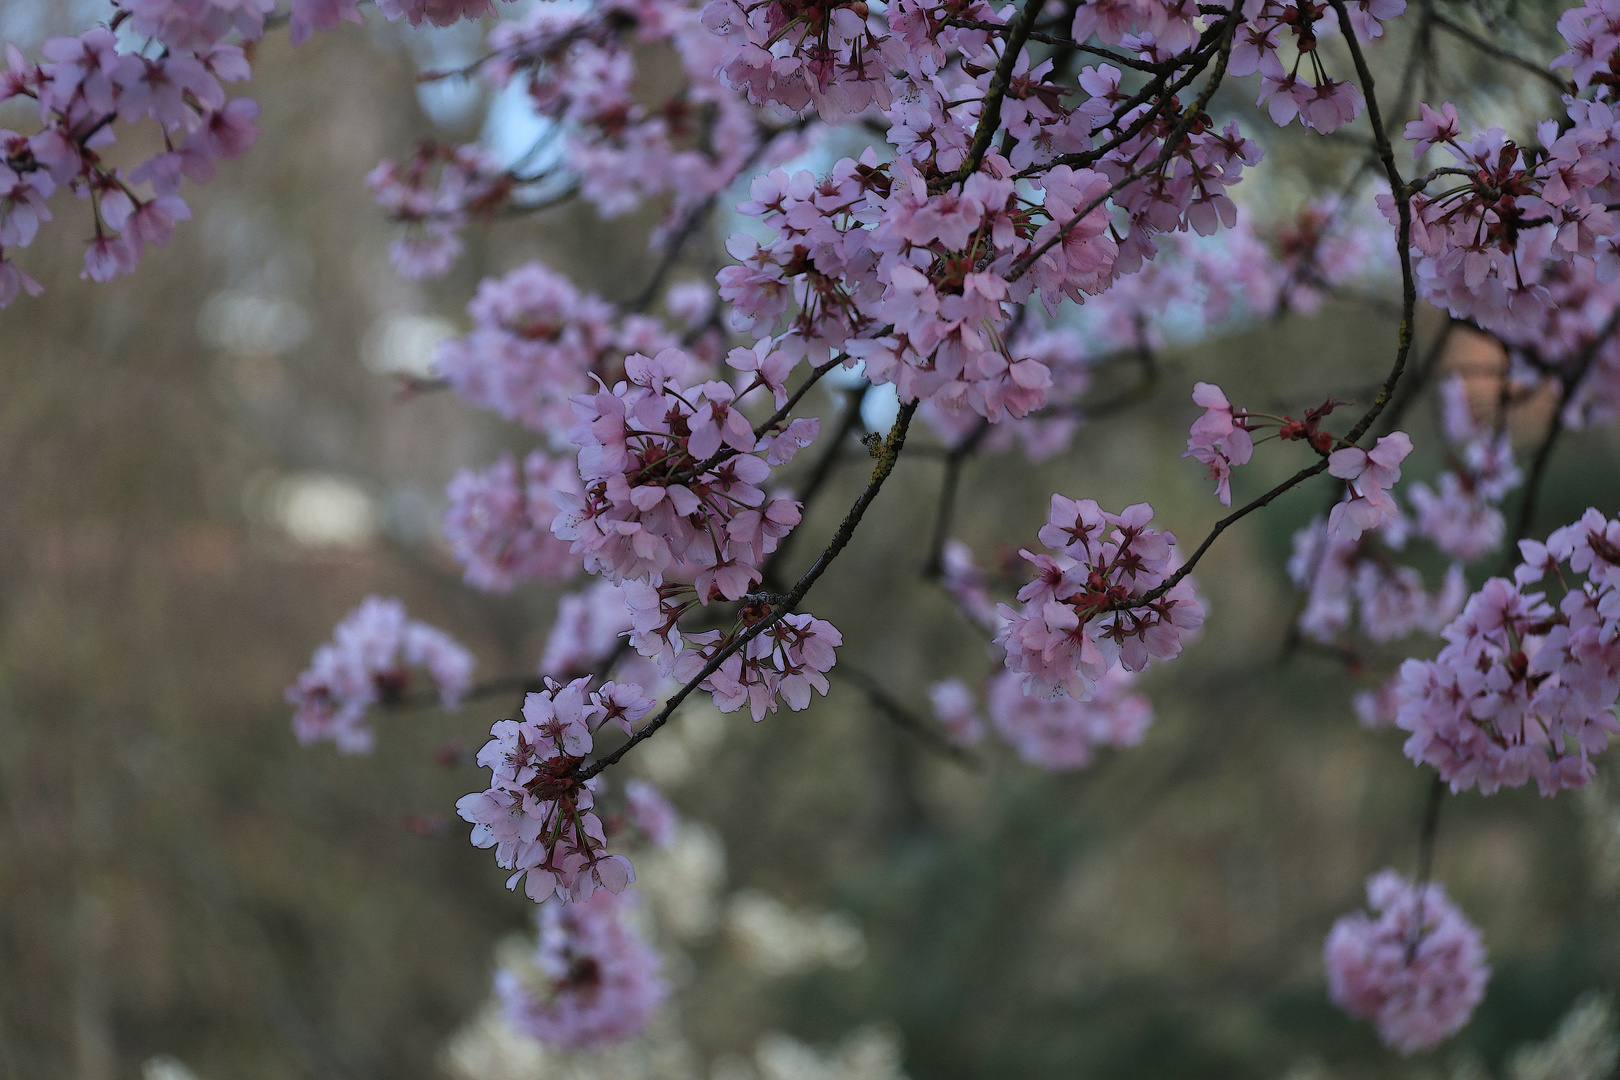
369, 0, 804, 278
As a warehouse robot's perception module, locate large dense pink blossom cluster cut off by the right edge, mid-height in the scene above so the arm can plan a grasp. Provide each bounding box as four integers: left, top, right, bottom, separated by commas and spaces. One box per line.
1396, 510, 1620, 795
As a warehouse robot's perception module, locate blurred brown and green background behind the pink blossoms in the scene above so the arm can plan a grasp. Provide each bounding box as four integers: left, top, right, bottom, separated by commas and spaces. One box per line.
0, 0, 1620, 1080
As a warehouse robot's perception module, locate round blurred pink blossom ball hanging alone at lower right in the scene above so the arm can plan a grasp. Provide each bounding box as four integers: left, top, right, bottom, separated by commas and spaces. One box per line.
1322, 870, 1490, 1054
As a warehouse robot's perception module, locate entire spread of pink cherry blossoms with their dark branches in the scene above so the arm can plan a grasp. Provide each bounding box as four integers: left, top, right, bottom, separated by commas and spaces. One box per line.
22, 0, 1620, 1052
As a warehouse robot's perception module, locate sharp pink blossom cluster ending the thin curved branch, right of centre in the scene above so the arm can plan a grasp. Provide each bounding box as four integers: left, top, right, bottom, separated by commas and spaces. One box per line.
996, 495, 1204, 701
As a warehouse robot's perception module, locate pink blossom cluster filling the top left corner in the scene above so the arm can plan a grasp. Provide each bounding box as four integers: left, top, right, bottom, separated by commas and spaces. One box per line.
0, 12, 255, 308
